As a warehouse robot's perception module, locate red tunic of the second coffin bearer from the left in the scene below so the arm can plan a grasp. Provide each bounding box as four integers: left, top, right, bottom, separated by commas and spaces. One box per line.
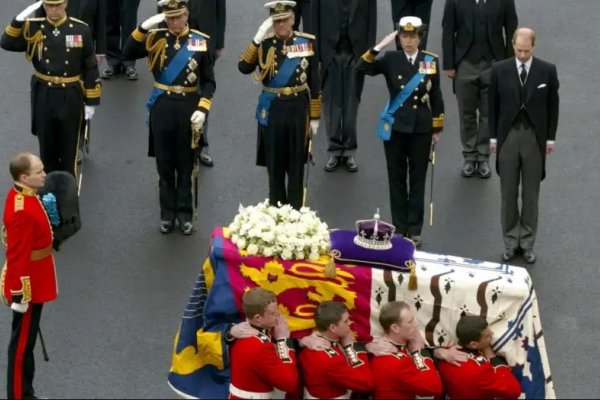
300, 343, 373, 399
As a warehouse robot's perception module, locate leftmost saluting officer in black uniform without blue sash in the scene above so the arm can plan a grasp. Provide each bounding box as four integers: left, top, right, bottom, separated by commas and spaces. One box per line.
0, 0, 100, 175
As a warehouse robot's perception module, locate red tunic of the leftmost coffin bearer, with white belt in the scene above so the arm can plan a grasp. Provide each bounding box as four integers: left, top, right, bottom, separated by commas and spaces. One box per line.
229, 333, 298, 399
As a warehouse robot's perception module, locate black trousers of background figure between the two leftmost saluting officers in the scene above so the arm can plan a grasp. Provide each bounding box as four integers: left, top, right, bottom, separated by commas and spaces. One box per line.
106, 0, 140, 67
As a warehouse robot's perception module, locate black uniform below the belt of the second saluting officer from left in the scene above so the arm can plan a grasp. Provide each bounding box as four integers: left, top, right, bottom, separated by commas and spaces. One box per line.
150, 94, 199, 222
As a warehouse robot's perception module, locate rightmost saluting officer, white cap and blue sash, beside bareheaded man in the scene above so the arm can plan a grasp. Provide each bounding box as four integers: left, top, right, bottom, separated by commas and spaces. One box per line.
357, 17, 444, 247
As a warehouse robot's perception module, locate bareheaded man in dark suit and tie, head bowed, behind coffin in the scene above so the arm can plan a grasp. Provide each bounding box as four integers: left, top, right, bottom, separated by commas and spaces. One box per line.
489, 28, 559, 264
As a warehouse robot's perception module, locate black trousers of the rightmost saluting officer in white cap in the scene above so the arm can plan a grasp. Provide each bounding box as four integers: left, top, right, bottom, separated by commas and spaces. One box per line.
383, 131, 432, 236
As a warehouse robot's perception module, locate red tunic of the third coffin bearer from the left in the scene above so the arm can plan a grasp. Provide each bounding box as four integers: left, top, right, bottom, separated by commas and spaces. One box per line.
370, 346, 442, 399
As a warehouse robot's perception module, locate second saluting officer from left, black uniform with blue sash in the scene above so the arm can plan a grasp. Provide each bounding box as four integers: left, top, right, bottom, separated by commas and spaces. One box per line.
123, 0, 215, 235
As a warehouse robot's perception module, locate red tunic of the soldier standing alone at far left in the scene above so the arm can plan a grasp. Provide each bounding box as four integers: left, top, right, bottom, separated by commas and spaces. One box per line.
1, 188, 58, 303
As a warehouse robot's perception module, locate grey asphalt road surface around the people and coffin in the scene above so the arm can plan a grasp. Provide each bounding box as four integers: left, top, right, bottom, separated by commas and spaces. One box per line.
0, 0, 600, 398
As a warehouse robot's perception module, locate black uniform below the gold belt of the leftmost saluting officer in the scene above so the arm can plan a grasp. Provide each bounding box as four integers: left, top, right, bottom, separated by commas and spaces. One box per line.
32, 78, 84, 175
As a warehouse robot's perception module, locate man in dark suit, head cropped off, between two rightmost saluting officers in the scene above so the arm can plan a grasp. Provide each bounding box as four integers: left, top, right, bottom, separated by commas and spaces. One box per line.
310, 0, 377, 172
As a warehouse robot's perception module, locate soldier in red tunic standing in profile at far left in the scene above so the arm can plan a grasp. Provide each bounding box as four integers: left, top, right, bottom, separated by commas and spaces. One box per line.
0, 153, 58, 399
